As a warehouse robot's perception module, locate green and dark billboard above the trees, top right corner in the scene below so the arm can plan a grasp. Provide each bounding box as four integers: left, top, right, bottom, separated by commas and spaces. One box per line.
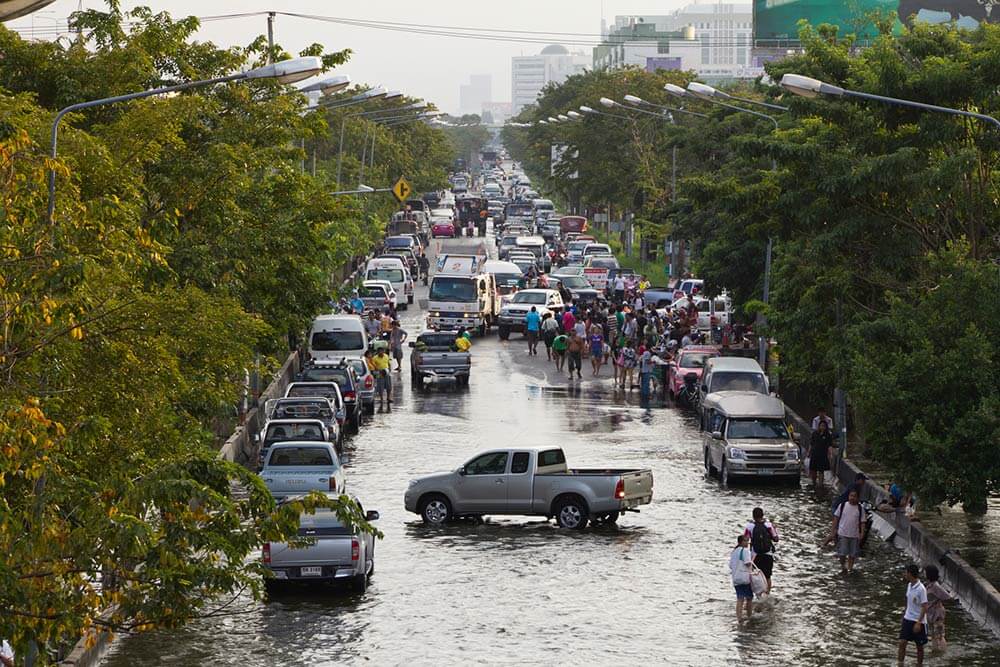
753, 0, 1000, 47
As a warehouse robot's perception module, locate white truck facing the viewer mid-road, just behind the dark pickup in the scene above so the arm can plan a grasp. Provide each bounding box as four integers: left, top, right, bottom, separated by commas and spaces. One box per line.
427, 255, 500, 336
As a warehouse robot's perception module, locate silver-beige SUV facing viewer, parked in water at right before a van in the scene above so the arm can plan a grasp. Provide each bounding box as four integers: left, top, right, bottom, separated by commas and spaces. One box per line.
702, 391, 801, 484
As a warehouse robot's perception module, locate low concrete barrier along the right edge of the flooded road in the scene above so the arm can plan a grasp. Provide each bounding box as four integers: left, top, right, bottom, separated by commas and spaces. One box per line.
785, 406, 1000, 635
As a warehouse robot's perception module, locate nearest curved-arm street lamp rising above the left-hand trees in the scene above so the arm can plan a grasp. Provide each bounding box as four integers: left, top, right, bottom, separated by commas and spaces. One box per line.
46, 56, 323, 226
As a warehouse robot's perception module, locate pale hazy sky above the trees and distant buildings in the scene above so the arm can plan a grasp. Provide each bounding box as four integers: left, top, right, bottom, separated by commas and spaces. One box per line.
7, 0, 692, 111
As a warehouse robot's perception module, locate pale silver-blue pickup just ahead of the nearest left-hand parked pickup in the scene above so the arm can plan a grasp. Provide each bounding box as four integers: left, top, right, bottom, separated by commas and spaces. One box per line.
259, 440, 345, 501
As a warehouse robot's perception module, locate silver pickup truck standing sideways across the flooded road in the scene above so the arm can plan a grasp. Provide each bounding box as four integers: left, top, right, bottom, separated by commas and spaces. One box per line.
403, 447, 653, 529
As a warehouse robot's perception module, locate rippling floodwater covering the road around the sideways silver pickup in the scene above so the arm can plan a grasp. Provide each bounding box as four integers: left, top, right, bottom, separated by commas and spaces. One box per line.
106, 241, 1000, 667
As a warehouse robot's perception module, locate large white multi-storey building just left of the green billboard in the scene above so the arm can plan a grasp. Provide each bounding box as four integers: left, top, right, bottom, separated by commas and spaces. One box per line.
593, 3, 762, 78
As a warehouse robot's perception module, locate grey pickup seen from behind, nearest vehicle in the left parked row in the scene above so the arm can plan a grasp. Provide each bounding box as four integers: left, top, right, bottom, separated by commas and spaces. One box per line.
261, 494, 379, 593
